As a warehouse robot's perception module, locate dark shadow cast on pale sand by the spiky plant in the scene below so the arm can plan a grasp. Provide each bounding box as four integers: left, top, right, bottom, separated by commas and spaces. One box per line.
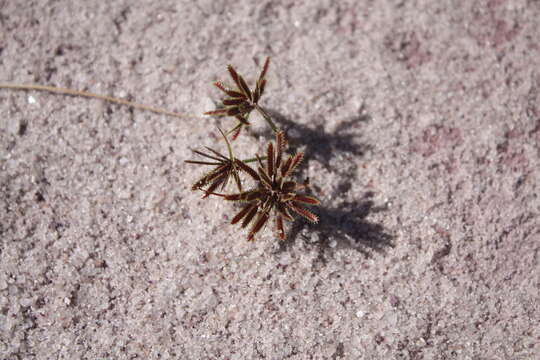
251, 107, 394, 262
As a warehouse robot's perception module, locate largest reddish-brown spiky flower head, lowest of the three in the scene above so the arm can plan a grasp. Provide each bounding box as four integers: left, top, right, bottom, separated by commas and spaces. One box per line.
216, 131, 319, 240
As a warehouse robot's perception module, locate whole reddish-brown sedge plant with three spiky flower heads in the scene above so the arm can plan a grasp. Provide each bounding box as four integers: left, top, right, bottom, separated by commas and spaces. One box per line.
186, 58, 319, 241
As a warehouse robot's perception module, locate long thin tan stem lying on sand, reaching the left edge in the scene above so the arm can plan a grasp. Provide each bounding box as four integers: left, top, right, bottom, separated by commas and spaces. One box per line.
0, 84, 198, 119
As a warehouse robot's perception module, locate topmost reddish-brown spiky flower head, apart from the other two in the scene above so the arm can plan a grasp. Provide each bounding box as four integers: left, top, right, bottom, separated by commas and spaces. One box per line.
204, 57, 277, 140
